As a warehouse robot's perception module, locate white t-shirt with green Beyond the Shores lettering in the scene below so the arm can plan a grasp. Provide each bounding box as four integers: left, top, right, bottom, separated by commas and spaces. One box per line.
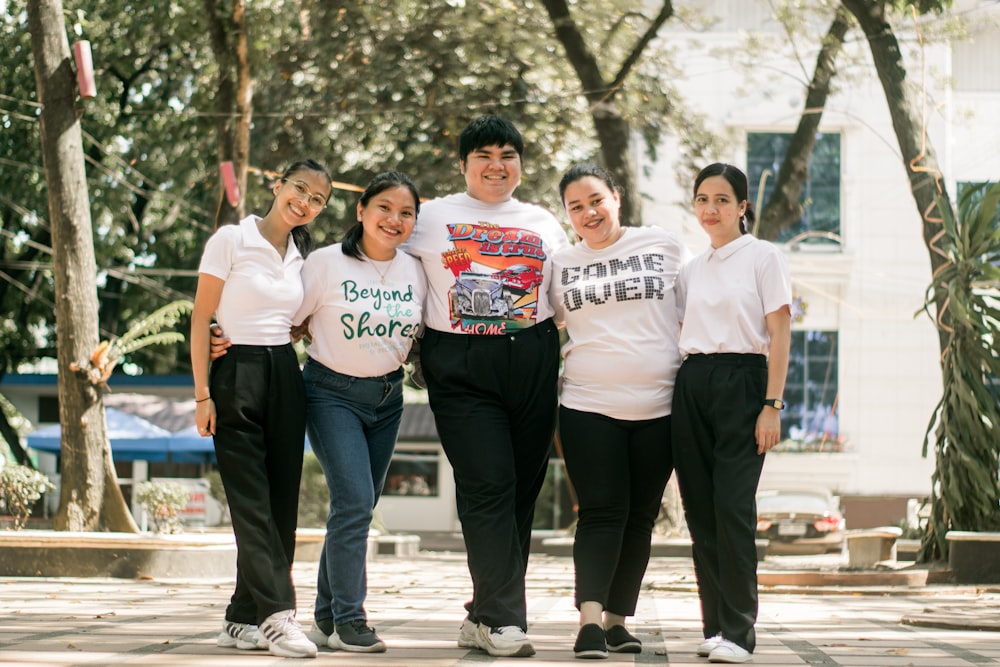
293, 243, 427, 377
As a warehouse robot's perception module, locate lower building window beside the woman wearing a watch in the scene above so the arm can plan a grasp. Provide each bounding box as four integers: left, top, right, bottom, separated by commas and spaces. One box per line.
780, 331, 844, 452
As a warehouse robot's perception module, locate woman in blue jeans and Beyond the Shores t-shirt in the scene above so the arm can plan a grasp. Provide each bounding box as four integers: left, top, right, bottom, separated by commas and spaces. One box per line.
293, 172, 425, 653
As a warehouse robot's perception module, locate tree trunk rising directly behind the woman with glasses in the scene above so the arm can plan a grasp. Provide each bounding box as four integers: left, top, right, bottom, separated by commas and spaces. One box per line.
205, 0, 253, 227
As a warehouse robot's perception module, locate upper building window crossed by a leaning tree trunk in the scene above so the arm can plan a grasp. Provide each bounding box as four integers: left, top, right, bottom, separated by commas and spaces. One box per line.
747, 132, 840, 247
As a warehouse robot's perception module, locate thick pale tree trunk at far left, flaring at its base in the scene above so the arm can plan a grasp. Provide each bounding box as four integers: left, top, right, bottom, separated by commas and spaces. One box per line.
28, 0, 138, 532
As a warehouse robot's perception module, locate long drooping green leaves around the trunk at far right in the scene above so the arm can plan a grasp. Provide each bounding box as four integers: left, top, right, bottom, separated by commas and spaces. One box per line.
920, 183, 1000, 560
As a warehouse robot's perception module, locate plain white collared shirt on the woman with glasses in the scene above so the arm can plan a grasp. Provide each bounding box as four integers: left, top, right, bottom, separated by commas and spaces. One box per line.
198, 215, 303, 345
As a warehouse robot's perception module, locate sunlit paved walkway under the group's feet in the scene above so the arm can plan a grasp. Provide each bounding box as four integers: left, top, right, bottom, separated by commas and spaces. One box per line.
0, 551, 1000, 667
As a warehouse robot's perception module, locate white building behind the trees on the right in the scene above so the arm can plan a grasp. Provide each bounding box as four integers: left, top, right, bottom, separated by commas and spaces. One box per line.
636, 0, 1000, 525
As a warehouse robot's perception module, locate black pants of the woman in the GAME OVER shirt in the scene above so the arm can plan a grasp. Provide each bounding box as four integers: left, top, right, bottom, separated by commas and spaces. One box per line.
559, 407, 673, 616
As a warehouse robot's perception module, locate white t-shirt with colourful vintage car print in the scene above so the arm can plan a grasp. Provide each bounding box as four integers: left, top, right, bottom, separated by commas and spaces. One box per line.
404, 193, 569, 335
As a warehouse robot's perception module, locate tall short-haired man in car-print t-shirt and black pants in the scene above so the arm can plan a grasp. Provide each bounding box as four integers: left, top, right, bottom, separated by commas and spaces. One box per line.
405, 115, 568, 657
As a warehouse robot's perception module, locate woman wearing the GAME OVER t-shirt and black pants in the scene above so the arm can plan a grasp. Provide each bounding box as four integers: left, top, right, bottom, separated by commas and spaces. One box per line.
550, 164, 690, 658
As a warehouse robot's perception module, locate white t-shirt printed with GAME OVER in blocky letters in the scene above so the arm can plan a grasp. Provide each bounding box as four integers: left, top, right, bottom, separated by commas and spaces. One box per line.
550, 227, 690, 421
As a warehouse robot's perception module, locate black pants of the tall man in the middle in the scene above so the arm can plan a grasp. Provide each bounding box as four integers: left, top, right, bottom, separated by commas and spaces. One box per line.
420, 320, 559, 629
